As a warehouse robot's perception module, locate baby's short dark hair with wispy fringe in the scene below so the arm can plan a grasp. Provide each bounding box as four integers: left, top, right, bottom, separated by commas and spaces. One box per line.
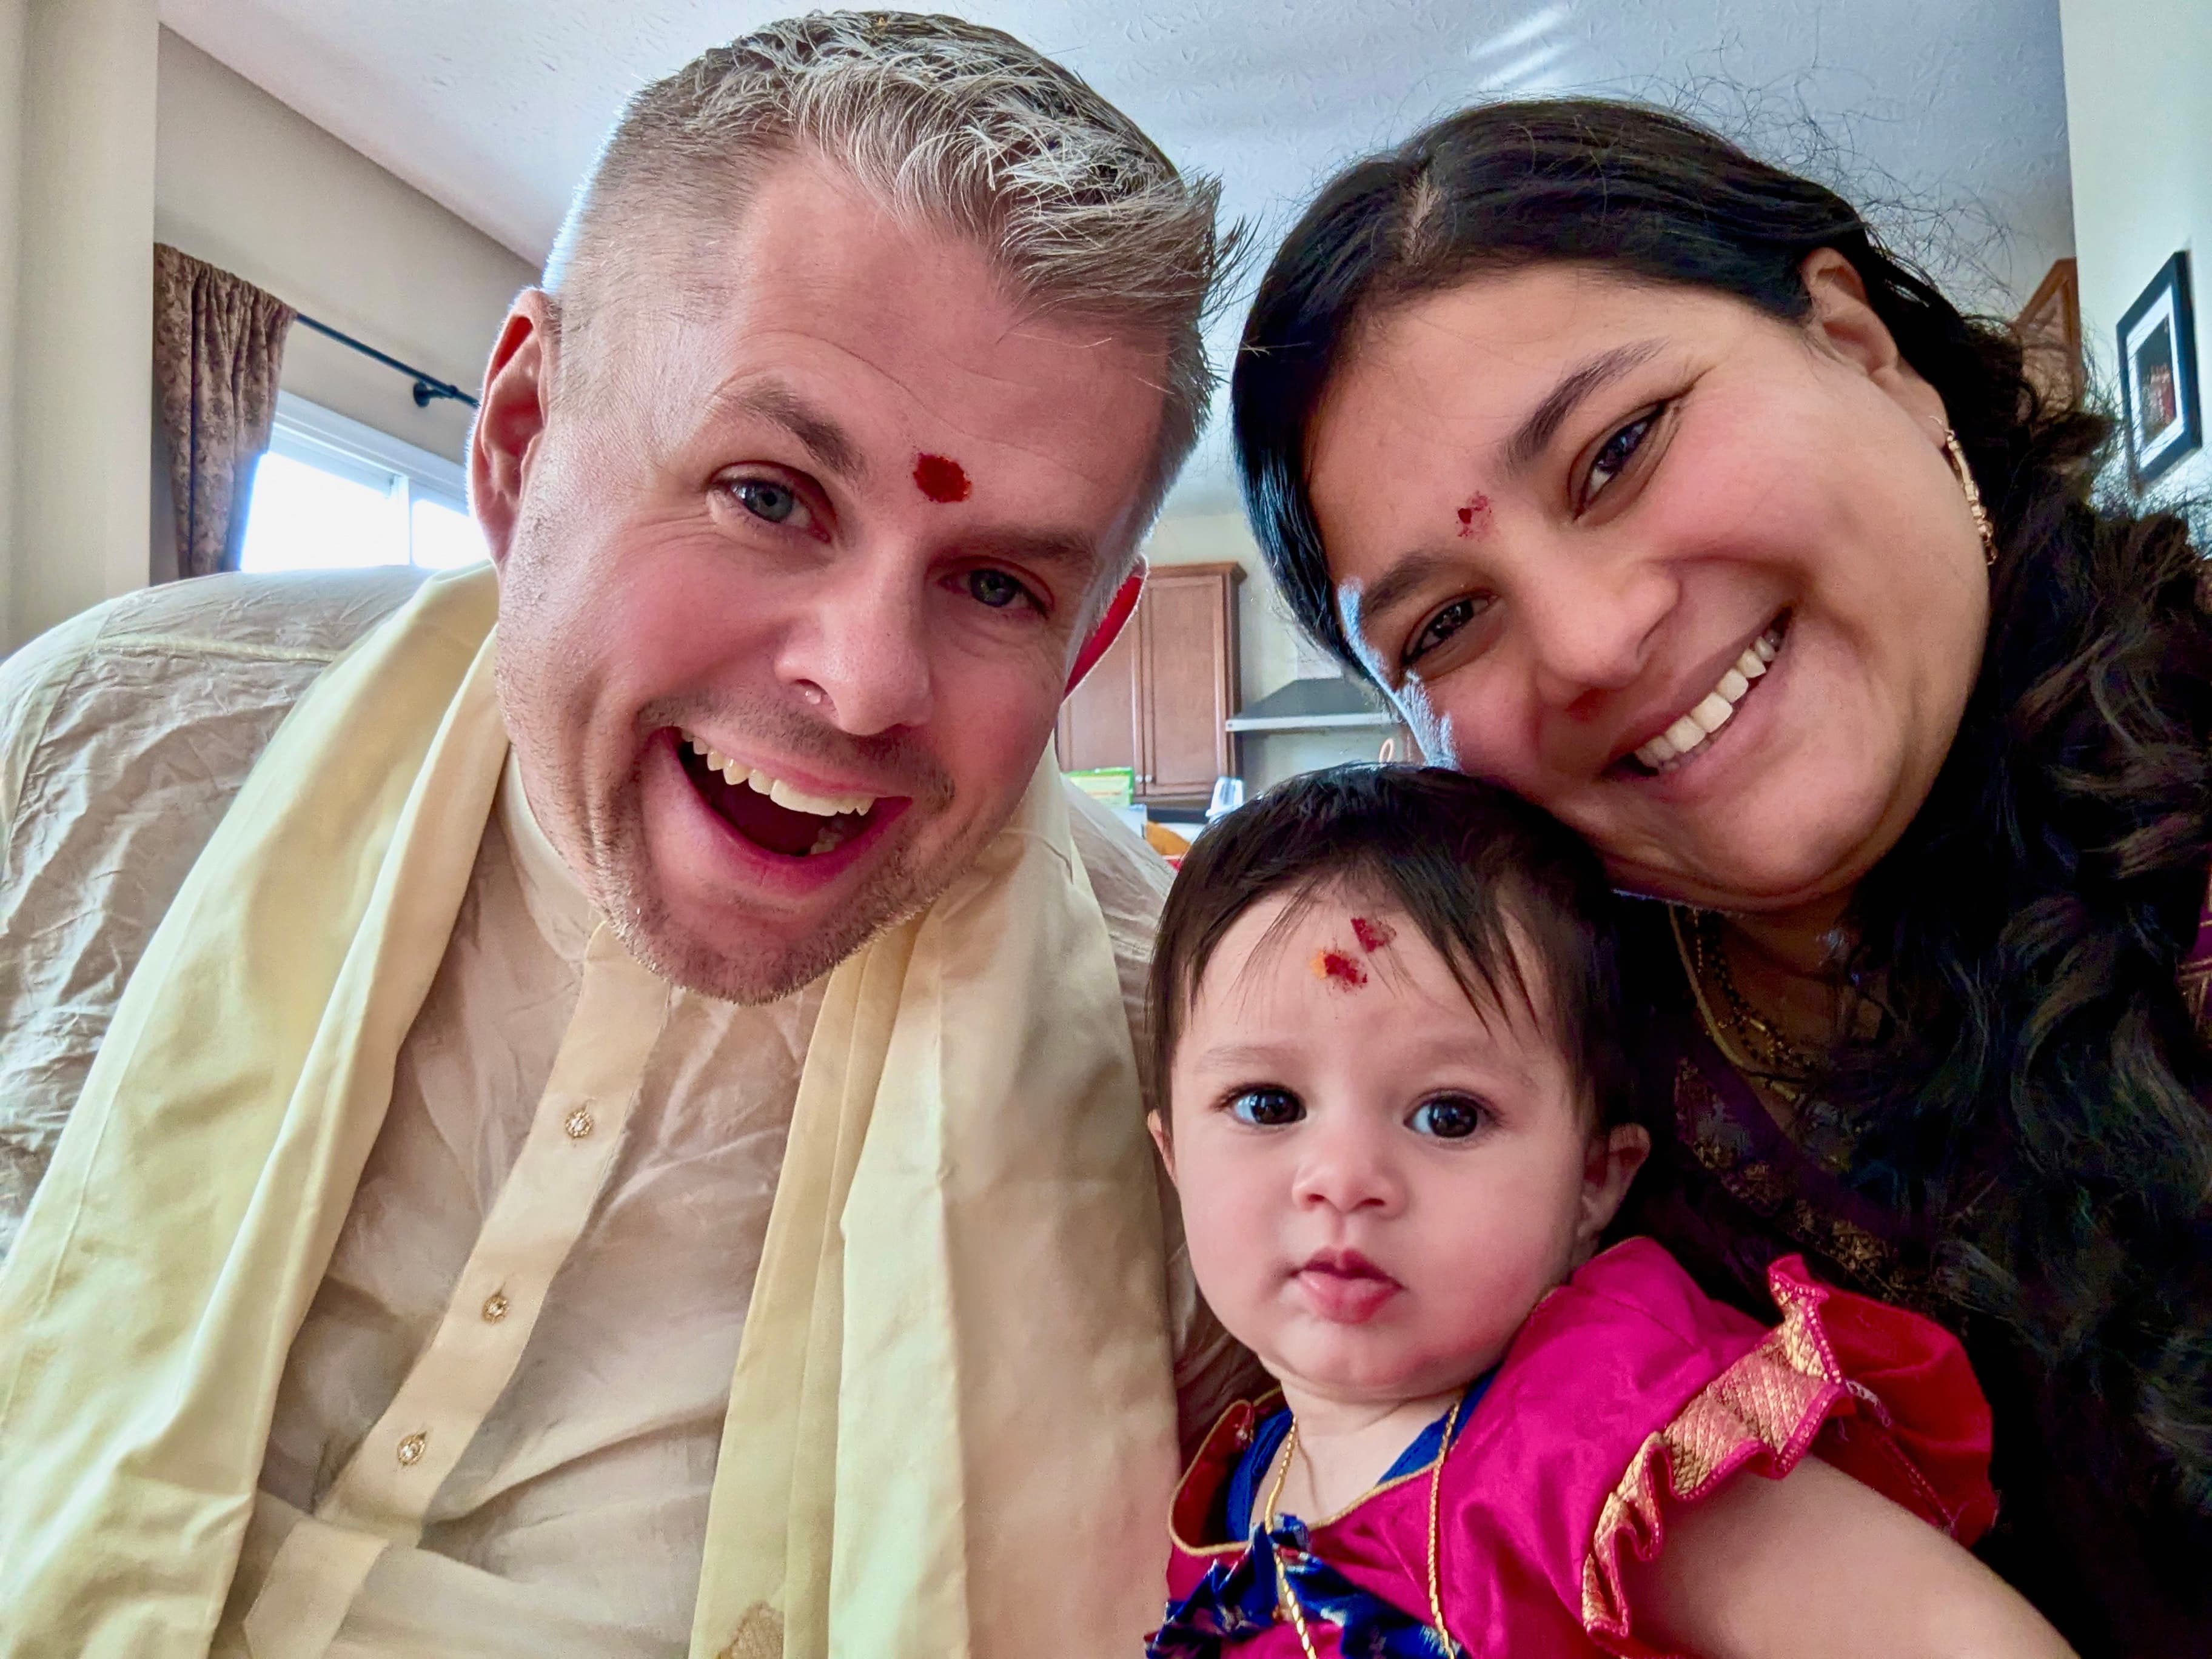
1146, 765, 1637, 1128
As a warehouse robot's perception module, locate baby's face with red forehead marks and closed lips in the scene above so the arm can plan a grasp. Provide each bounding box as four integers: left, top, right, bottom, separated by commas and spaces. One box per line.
1161, 894, 1641, 1403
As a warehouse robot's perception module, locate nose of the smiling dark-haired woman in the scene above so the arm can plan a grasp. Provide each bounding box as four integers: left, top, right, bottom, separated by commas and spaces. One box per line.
1509, 549, 1679, 712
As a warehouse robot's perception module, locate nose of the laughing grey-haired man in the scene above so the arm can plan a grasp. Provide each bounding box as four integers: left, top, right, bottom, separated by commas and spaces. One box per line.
776, 557, 933, 737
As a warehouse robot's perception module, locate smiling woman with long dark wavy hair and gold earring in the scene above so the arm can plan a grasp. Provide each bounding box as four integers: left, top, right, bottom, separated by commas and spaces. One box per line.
1235, 102, 2212, 1655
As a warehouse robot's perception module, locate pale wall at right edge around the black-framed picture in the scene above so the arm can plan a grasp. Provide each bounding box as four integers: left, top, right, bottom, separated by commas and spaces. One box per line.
2059, 0, 2212, 506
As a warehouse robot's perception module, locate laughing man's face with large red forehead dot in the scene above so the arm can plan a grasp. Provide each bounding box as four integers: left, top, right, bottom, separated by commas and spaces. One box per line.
474, 159, 1164, 1002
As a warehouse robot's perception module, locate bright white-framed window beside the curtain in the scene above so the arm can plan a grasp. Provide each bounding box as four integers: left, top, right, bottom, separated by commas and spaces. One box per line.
239, 392, 484, 571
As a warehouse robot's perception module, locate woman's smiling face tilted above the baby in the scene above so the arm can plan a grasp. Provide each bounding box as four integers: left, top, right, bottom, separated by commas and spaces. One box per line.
1307, 252, 1989, 911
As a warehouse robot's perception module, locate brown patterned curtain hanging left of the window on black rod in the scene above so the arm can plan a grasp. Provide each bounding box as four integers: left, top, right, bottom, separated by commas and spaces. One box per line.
153, 243, 294, 575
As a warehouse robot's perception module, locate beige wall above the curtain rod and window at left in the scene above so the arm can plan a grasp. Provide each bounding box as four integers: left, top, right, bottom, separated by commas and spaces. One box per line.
155, 28, 537, 460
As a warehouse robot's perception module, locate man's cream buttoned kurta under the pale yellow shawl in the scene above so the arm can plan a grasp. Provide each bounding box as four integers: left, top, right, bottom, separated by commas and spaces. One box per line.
0, 580, 1241, 1655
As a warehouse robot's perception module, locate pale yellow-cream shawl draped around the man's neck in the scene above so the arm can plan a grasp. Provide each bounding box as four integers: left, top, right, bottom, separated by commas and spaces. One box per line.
0, 569, 1175, 1659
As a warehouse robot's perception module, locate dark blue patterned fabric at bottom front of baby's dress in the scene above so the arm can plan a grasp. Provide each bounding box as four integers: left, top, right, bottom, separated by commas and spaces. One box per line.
1144, 1515, 1462, 1659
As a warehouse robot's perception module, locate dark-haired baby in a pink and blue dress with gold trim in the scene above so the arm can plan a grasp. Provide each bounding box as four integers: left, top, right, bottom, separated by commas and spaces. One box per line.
1148, 765, 2066, 1659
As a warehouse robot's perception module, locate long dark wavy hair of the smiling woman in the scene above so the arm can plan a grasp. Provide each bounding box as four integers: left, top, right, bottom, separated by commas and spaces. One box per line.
1232, 99, 2212, 1566
